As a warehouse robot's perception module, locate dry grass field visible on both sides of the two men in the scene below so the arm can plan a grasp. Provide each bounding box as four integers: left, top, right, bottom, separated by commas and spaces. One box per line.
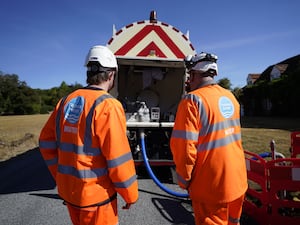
0, 114, 300, 161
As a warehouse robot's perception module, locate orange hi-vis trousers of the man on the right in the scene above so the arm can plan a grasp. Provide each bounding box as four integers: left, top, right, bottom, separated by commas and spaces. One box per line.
192, 195, 244, 225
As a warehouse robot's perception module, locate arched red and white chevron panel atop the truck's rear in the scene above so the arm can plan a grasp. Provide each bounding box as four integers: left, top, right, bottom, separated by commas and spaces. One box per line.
107, 20, 196, 59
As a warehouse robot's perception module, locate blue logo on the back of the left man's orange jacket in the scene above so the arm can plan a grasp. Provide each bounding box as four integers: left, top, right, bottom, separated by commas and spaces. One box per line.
64, 96, 84, 124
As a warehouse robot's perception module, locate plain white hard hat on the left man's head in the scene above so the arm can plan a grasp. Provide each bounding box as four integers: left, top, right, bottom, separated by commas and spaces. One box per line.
84, 45, 118, 69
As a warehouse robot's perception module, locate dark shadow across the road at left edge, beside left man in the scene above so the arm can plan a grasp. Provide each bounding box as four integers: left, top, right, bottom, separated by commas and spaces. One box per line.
0, 148, 55, 194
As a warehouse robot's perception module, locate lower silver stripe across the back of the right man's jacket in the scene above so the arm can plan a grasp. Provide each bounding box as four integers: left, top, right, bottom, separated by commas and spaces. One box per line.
197, 134, 241, 151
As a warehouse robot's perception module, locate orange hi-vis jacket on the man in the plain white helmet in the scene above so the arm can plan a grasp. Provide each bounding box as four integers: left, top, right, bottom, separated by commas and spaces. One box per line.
39, 87, 138, 207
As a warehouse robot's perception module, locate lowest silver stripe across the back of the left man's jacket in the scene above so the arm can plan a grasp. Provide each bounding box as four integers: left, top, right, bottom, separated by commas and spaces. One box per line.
58, 165, 107, 179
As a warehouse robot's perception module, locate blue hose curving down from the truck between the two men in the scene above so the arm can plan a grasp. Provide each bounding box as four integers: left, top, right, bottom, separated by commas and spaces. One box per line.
141, 132, 189, 198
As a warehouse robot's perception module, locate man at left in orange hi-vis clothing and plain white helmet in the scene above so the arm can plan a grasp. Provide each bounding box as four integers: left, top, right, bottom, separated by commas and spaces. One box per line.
39, 45, 138, 225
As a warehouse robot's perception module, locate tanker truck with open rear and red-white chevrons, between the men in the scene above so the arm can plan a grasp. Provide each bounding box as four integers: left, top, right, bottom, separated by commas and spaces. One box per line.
107, 11, 195, 169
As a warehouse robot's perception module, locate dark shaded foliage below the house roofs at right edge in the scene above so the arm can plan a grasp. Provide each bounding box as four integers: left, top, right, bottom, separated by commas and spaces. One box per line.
242, 69, 300, 117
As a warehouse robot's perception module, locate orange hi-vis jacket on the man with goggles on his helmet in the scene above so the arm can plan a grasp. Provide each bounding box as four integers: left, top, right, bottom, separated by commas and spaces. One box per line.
170, 83, 248, 203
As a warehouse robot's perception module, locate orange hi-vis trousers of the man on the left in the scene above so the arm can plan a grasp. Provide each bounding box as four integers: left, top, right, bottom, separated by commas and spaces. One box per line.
67, 199, 119, 225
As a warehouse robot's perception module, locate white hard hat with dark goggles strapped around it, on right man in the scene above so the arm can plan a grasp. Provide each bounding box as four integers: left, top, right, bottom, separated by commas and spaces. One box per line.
185, 52, 218, 75
